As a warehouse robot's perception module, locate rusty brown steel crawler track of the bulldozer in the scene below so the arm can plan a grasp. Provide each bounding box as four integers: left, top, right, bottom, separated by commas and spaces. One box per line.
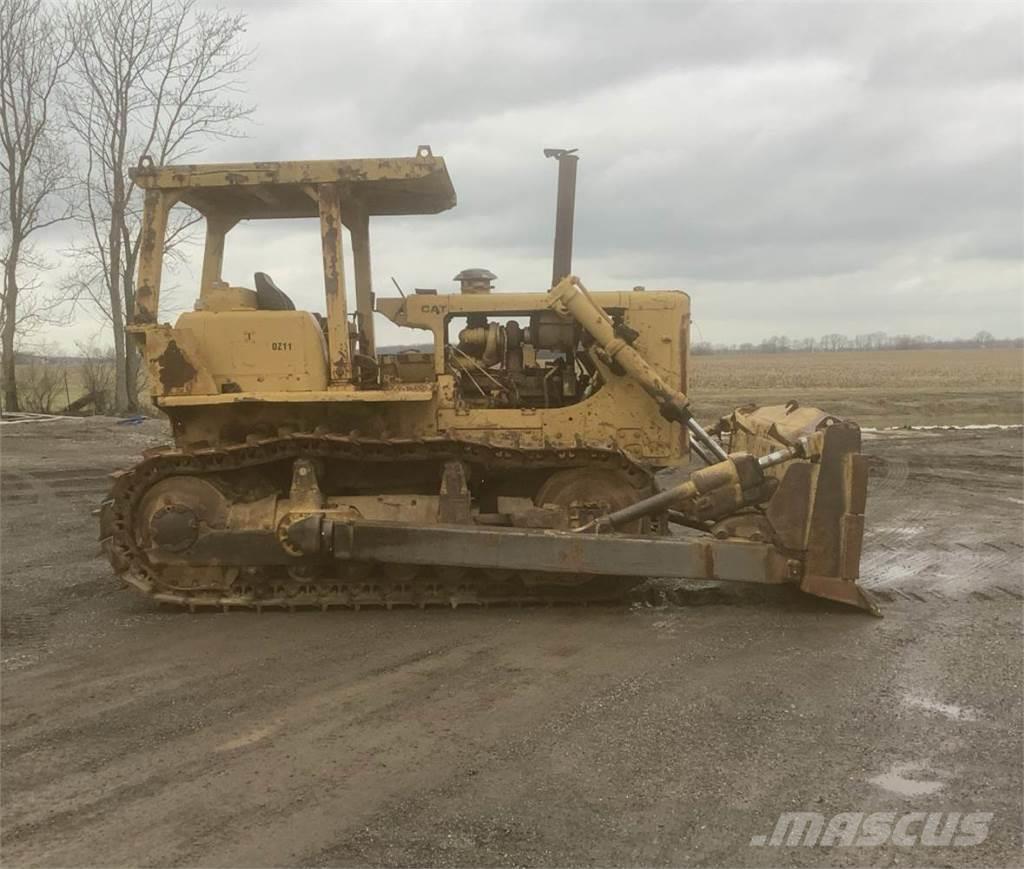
100, 434, 651, 609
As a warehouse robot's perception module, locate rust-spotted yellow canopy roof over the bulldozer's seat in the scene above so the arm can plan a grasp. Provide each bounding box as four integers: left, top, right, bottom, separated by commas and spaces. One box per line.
131, 145, 456, 220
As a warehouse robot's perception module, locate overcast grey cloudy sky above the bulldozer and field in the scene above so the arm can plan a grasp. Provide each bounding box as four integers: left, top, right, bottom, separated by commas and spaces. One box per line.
41, 0, 1024, 344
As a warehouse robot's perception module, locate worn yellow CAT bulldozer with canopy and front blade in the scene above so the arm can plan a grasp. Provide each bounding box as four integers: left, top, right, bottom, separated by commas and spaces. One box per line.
100, 146, 877, 612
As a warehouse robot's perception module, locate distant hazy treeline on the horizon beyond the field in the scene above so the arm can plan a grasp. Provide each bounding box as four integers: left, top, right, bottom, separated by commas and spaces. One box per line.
690, 332, 1024, 356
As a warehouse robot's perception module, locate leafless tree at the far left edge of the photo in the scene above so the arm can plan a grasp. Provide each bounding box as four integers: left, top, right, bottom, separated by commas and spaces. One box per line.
0, 0, 72, 410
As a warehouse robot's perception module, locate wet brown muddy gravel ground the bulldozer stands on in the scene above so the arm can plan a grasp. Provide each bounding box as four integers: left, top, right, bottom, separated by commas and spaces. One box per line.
0, 419, 1024, 866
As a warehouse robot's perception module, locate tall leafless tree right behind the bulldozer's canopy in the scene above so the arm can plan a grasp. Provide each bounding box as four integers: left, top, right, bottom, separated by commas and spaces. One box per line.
67, 0, 252, 411
